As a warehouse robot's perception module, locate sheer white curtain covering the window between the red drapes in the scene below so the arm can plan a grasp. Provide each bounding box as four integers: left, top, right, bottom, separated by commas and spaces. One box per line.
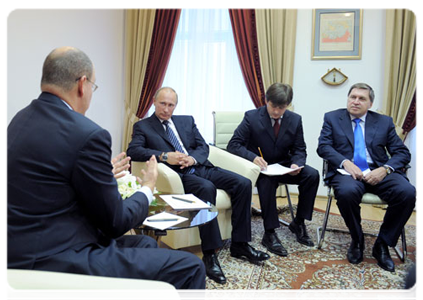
149, 8, 254, 143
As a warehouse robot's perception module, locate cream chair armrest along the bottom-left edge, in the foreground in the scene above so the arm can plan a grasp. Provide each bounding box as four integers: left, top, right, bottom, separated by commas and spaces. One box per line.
5, 269, 180, 300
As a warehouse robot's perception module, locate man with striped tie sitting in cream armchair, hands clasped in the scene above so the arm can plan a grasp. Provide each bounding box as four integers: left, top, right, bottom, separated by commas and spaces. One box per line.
127, 87, 269, 283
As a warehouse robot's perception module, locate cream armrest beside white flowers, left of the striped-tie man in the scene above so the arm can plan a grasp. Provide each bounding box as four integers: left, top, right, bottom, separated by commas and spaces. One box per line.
131, 161, 185, 194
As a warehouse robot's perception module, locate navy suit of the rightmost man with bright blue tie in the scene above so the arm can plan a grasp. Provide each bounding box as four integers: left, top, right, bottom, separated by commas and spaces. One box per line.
317, 109, 417, 246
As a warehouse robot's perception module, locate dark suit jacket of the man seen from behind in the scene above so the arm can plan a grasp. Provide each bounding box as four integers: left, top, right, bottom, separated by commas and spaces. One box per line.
5, 93, 148, 274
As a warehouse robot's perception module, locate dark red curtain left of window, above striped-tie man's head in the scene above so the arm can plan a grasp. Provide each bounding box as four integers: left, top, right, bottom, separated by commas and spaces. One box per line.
137, 8, 182, 118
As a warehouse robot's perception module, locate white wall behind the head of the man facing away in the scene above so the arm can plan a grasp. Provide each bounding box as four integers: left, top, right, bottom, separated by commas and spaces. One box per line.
5, 9, 124, 155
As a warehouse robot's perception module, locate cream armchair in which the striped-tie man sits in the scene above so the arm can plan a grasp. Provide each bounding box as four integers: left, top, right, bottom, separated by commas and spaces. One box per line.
131, 146, 260, 249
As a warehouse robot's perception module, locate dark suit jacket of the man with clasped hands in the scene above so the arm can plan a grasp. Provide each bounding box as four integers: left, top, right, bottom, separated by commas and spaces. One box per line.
127, 114, 213, 173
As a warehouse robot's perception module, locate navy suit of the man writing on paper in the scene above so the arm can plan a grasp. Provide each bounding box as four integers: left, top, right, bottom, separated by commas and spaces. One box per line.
227, 106, 319, 230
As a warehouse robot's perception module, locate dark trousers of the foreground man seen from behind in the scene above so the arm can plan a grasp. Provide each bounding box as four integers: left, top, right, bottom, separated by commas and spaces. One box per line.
34, 235, 205, 299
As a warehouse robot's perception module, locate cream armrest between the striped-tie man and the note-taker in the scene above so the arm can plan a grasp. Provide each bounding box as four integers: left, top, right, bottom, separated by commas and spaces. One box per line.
209, 145, 260, 186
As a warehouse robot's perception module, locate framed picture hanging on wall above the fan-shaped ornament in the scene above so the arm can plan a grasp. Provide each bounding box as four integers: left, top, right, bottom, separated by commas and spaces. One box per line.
311, 8, 363, 59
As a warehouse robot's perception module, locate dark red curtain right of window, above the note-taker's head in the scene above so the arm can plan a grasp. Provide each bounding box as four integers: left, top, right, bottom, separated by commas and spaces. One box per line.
229, 8, 265, 107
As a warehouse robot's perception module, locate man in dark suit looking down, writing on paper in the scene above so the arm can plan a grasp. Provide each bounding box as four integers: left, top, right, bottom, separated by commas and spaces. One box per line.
227, 83, 319, 256
